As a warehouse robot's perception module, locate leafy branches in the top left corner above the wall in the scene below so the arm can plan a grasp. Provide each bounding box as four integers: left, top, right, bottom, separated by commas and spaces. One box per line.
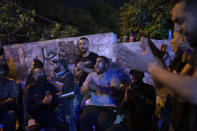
0, 2, 35, 44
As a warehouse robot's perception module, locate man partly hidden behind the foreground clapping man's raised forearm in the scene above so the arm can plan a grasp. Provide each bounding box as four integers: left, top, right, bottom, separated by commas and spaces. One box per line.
168, 29, 192, 131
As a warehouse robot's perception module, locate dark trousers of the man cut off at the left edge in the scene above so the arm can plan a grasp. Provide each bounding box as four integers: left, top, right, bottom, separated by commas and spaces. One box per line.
0, 110, 16, 131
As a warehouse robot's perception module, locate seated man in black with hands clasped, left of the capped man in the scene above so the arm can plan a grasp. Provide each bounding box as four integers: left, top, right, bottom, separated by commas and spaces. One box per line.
25, 68, 57, 130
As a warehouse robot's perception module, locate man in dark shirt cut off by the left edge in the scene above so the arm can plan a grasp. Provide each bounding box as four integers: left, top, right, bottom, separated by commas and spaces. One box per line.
0, 63, 18, 131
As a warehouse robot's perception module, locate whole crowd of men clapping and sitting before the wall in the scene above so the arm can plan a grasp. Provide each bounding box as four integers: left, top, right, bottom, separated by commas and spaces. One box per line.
0, 0, 197, 131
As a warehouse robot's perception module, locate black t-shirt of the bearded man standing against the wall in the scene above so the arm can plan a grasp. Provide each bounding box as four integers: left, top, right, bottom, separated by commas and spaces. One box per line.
77, 52, 98, 86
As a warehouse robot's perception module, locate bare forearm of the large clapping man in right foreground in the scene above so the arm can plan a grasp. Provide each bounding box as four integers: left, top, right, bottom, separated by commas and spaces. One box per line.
148, 63, 197, 104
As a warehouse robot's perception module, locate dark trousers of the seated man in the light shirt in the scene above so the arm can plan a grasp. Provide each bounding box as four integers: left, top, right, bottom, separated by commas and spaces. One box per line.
80, 106, 116, 131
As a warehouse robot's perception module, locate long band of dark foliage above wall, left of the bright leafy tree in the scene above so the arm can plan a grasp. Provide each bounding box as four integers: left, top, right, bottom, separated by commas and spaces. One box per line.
0, 0, 120, 44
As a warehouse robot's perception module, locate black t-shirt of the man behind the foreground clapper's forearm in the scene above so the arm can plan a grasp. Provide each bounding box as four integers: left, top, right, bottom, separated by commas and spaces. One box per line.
170, 52, 191, 131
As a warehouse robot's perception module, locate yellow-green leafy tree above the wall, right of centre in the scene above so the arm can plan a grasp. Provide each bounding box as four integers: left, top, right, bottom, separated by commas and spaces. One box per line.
120, 0, 172, 40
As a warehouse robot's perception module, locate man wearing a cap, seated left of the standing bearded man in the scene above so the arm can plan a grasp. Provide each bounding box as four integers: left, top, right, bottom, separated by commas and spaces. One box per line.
53, 58, 74, 130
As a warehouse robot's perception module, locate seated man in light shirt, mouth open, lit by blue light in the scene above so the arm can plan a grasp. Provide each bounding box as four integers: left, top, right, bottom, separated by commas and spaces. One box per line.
80, 56, 123, 131
